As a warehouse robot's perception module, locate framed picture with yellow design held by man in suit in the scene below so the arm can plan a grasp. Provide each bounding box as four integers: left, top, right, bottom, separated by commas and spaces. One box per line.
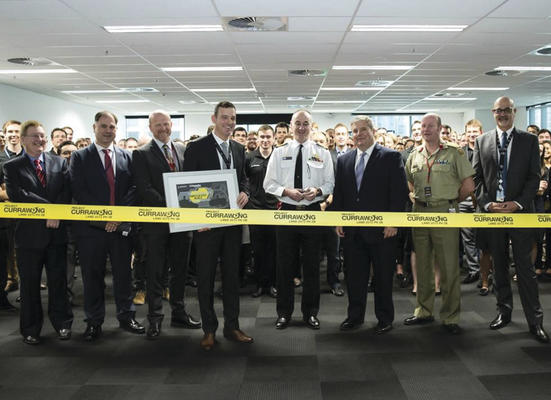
163, 169, 239, 233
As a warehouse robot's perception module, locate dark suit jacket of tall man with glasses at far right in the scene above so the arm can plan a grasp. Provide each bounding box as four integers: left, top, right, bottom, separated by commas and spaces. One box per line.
473, 129, 541, 213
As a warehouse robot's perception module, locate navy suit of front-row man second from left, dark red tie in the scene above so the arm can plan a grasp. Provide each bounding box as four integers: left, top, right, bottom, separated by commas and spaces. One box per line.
70, 144, 136, 326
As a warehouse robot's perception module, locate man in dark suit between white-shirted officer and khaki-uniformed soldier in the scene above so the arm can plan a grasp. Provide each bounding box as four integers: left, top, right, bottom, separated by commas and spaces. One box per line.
332, 116, 408, 334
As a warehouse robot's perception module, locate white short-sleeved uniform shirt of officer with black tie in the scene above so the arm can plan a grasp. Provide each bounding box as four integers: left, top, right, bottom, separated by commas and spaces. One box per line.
264, 140, 335, 205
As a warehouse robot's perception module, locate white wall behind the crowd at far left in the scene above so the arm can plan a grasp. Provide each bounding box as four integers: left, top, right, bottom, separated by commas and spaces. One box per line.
0, 84, 99, 138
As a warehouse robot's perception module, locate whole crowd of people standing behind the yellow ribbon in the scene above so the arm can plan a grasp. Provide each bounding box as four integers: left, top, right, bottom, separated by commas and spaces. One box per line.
0, 97, 551, 350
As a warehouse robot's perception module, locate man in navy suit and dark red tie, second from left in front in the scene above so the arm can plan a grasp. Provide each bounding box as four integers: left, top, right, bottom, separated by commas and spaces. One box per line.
70, 111, 145, 341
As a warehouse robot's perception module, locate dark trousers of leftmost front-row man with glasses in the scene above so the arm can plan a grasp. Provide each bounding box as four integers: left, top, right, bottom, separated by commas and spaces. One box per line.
17, 244, 73, 336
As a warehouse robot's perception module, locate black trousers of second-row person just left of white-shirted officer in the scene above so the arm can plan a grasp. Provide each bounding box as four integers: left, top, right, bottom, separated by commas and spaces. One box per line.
249, 225, 276, 288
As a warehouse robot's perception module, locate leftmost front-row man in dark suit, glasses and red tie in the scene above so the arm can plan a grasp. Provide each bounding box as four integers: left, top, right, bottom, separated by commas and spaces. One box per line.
4, 121, 73, 344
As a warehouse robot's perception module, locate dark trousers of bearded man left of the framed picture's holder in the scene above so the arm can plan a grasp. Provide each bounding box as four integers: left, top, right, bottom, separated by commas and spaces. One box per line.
143, 232, 191, 322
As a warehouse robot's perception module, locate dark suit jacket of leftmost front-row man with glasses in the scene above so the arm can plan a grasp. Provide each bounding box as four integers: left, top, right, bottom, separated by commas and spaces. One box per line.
4, 153, 71, 249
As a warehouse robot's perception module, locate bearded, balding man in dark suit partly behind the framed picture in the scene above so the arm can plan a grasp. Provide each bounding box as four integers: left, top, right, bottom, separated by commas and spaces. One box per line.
132, 111, 201, 339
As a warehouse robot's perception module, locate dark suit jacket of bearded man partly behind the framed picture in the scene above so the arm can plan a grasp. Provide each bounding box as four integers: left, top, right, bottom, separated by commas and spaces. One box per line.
132, 140, 185, 233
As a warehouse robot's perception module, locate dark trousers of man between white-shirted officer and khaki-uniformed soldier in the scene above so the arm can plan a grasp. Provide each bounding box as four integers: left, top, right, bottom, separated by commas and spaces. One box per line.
343, 232, 396, 324
